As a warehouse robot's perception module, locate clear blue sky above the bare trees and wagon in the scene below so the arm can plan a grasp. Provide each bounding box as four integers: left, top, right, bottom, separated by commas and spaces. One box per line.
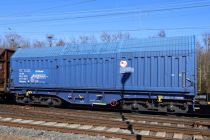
0, 0, 210, 40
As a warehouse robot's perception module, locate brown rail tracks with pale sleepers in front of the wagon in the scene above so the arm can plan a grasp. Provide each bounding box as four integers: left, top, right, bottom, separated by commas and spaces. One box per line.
0, 105, 210, 140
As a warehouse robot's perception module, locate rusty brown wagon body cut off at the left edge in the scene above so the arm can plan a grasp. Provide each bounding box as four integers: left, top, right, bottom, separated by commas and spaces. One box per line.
0, 48, 14, 93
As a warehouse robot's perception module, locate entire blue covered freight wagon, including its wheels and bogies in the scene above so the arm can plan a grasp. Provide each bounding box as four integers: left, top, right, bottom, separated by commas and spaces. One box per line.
10, 36, 197, 112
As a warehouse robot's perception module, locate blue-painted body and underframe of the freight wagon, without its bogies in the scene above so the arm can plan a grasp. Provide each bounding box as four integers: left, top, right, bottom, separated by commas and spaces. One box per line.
11, 37, 197, 104
